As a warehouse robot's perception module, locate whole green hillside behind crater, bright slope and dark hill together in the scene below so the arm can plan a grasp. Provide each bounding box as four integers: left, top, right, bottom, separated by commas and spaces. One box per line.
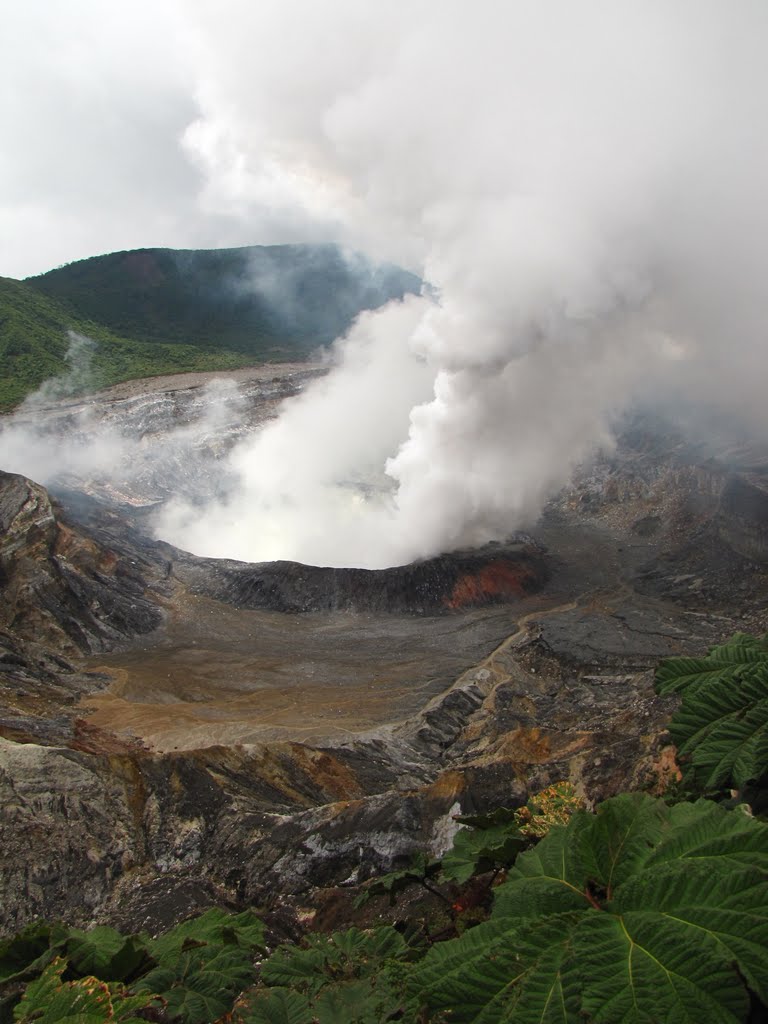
0, 246, 421, 411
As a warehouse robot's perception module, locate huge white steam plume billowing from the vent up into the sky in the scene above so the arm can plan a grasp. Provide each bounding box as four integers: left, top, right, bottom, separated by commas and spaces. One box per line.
158, 0, 768, 566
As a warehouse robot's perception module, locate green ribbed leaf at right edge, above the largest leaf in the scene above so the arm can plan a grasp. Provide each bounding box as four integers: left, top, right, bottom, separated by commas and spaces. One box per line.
656, 633, 768, 803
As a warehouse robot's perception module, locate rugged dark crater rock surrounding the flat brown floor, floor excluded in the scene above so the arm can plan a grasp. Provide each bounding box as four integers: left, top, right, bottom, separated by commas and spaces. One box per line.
0, 411, 768, 932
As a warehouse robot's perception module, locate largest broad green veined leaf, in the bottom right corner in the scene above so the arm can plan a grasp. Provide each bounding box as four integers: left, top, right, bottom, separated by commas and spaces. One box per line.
409, 794, 768, 1024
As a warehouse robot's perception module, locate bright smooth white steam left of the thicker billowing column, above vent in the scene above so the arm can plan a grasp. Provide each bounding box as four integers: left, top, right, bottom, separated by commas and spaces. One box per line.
156, 297, 433, 565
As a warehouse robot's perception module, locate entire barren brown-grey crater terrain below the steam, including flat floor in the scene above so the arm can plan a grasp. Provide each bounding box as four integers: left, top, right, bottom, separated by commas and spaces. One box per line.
0, 370, 768, 932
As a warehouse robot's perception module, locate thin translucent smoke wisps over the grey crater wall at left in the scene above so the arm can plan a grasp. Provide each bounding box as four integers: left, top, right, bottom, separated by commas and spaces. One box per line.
0, 339, 245, 505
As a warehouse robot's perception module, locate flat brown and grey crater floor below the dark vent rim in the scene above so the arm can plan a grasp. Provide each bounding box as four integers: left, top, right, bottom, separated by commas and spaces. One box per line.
82, 596, 528, 751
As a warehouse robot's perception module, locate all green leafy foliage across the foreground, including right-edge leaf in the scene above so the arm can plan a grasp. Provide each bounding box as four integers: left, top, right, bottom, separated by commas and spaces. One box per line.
0, 634, 768, 1024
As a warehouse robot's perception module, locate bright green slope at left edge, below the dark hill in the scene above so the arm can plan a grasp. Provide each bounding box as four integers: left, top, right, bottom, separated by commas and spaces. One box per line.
0, 278, 253, 412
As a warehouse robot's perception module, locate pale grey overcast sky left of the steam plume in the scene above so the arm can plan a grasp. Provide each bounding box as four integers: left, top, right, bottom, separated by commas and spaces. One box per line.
0, 0, 350, 278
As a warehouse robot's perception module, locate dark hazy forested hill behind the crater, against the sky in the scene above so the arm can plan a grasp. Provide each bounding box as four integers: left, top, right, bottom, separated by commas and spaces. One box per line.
26, 245, 421, 358
